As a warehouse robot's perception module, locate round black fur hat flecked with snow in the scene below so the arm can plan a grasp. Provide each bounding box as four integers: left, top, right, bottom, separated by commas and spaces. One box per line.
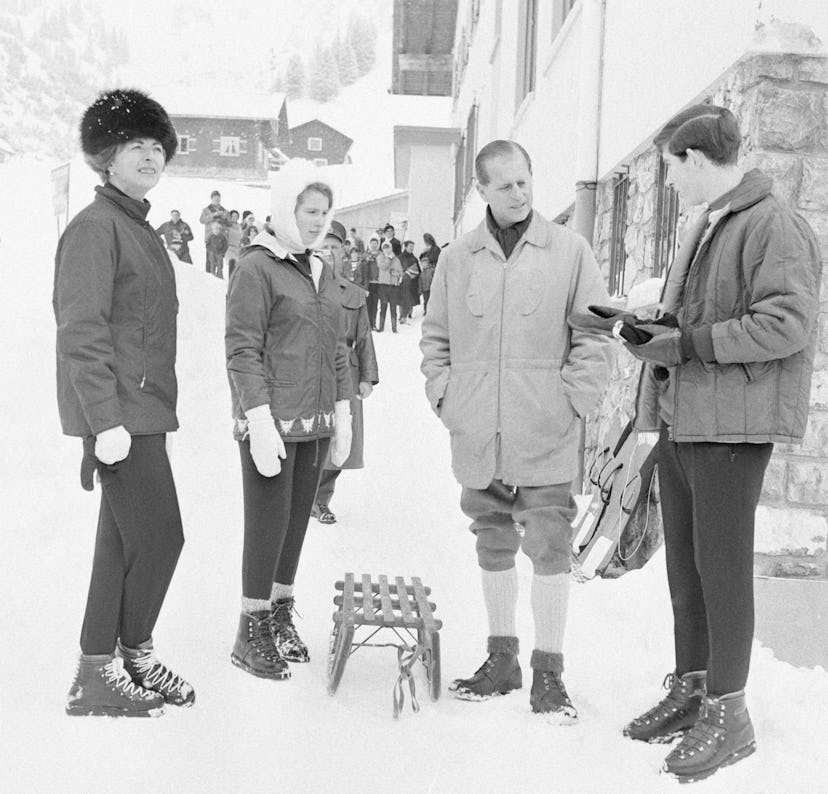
80, 88, 178, 162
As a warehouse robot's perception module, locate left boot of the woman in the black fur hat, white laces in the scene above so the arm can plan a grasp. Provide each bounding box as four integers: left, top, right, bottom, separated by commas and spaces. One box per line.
66, 654, 164, 717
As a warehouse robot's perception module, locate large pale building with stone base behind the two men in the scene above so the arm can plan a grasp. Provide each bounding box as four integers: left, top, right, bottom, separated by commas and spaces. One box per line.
414, 0, 828, 576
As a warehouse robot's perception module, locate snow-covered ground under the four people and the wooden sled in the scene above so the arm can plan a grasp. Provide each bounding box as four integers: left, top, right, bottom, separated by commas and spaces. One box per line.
0, 163, 828, 794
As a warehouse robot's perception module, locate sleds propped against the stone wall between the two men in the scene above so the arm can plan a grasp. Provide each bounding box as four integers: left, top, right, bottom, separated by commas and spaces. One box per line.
572, 423, 662, 581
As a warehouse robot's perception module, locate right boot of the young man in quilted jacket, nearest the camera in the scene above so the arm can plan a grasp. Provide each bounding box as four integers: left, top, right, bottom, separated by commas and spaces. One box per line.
662, 690, 756, 783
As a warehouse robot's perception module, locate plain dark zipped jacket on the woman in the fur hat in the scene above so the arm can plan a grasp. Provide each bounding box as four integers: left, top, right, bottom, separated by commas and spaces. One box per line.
52, 185, 178, 437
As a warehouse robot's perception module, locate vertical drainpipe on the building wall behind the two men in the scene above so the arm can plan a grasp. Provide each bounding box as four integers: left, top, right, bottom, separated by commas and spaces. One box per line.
573, 0, 606, 493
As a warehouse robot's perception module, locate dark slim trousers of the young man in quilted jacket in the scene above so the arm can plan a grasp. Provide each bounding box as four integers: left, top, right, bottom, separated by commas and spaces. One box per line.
658, 428, 773, 695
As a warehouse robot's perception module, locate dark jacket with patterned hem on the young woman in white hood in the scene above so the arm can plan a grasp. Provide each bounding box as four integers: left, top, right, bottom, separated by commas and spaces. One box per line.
225, 232, 354, 441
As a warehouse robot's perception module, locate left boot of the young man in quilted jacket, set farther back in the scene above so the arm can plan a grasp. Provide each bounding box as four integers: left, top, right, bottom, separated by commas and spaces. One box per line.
624, 670, 707, 744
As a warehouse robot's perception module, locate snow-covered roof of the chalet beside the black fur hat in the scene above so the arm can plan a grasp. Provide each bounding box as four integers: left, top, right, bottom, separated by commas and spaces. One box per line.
153, 86, 285, 120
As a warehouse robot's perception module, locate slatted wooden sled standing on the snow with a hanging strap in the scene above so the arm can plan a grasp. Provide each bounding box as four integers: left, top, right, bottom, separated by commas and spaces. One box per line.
328, 573, 443, 719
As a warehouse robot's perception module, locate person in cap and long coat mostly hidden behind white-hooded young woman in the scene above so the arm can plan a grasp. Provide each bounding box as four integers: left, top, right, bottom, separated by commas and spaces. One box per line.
311, 221, 379, 524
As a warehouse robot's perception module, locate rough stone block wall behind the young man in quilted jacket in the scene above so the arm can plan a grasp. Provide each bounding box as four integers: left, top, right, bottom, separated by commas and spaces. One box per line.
586, 53, 828, 575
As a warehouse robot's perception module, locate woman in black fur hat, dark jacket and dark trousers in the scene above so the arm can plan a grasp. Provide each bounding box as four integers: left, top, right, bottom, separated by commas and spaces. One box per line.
52, 89, 195, 717
